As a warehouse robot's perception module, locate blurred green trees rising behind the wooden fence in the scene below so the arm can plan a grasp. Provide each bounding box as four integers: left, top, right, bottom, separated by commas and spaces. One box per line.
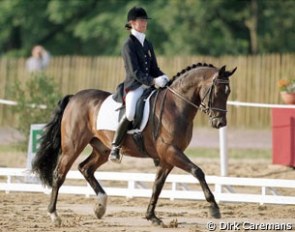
0, 0, 295, 56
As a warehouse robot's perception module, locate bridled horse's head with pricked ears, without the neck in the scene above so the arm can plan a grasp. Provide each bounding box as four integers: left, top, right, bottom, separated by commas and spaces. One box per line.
199, 66, 237, 128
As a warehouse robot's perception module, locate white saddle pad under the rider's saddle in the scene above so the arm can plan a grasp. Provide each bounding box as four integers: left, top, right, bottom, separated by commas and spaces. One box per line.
96, 91, 154, 134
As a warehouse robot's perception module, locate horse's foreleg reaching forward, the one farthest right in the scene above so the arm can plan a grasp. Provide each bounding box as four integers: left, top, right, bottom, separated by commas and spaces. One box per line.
167, 147, 221, 218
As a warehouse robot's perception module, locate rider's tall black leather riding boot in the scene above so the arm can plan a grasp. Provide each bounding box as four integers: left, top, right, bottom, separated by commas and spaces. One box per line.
110, 116, 131, 163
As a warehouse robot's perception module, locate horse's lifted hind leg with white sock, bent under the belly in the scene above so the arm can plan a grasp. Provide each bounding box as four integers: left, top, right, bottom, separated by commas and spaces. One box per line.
79, 139, 110, 219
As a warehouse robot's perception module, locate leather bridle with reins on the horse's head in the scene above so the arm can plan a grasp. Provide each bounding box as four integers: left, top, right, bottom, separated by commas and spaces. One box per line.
167, 77, 229, 117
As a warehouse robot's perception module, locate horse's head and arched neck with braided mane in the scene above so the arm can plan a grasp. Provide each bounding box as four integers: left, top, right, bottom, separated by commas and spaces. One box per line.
168, 63, 237, 128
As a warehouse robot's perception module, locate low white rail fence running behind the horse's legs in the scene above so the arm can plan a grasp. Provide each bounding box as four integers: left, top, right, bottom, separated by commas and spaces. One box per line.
0, 168, 295, 205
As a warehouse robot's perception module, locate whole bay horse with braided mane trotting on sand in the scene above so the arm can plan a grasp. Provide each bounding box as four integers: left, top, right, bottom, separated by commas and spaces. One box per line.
32, 63, 236, 225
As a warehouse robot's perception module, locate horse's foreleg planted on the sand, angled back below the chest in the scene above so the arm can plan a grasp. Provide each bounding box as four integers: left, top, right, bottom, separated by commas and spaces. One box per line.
146, 166, 172, 225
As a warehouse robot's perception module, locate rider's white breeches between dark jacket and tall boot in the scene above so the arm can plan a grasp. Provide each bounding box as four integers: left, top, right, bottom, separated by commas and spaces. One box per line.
125, 86, 145, 121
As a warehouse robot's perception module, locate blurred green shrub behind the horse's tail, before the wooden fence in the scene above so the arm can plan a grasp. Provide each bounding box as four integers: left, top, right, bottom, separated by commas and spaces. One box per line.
12, 73, 61, 147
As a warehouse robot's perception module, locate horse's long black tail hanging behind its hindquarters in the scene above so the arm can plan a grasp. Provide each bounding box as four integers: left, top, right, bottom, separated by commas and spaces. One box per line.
32, 95, 73, 187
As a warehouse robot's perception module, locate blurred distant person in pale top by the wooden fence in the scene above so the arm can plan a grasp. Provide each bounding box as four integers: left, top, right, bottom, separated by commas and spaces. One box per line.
26, 45, 50, 72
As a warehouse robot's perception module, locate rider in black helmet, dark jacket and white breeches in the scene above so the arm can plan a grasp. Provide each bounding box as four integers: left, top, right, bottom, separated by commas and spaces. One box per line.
110, 7, 169, 163
